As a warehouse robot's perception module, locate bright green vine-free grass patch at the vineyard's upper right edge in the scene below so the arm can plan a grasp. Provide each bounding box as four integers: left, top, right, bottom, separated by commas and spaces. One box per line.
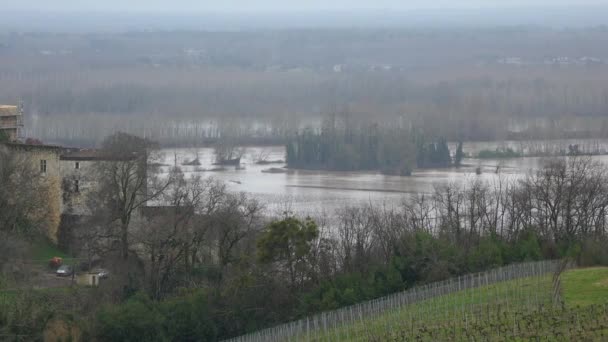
562, 267, 608, 306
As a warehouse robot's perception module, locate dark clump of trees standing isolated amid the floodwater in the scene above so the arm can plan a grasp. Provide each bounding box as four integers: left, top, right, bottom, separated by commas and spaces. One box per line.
286, 116, 463, 176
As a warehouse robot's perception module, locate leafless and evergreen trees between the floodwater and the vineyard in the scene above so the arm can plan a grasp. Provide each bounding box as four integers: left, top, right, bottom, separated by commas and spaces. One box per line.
0, 134, 608, 341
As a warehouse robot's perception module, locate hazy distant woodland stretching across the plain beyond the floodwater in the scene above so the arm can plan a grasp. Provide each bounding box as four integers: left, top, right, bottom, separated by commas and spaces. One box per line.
0, 28, 608, 146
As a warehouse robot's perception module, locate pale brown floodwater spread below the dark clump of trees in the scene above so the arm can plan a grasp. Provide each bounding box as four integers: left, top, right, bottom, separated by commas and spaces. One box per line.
163, 145, 608, 214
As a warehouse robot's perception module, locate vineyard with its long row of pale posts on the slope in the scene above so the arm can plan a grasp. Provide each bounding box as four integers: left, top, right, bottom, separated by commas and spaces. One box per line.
224, 262, 608, 342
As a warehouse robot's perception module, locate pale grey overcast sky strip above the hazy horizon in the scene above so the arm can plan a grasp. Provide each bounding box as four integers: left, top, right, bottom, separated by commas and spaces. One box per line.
0, 0, 608, 15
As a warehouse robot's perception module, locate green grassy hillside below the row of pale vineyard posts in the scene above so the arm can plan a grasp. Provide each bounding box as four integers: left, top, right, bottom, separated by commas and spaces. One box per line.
286, 268, 608, 341
